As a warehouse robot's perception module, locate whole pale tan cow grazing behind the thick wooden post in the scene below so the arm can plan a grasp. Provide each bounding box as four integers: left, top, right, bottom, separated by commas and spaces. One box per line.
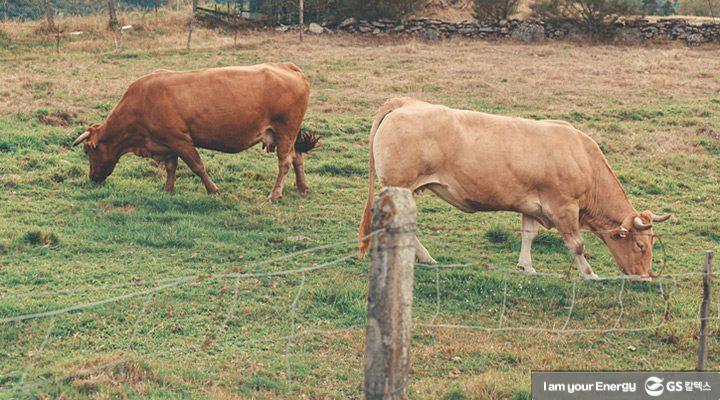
358, 98, 670, 280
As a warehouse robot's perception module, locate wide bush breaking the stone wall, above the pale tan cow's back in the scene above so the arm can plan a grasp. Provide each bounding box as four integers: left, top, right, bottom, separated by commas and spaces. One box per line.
531, 0, 638, 39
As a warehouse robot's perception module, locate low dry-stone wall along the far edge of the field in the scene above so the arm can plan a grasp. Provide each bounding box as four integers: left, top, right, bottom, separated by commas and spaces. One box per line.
323, 18, 720, 45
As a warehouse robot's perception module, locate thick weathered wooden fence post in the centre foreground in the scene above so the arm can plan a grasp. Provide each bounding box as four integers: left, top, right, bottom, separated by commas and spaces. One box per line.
363, 187, 417, 400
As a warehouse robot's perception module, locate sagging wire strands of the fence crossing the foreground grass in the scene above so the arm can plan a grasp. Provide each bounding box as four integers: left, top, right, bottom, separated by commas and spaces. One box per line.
0, 226, 720, 391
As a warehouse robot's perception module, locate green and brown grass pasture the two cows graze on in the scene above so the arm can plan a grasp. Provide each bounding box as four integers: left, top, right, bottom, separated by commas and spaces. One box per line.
0, 9, 720, 399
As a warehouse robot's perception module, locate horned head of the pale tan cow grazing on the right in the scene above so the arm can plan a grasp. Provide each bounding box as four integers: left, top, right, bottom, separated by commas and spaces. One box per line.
601, 211, 670, 280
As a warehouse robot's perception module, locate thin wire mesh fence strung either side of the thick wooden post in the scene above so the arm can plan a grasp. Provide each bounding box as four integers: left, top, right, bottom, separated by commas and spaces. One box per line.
0, 227, 720, 393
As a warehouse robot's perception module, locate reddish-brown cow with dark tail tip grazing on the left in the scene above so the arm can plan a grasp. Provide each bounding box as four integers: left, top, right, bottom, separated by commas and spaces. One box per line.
73, 63, 317, 200
